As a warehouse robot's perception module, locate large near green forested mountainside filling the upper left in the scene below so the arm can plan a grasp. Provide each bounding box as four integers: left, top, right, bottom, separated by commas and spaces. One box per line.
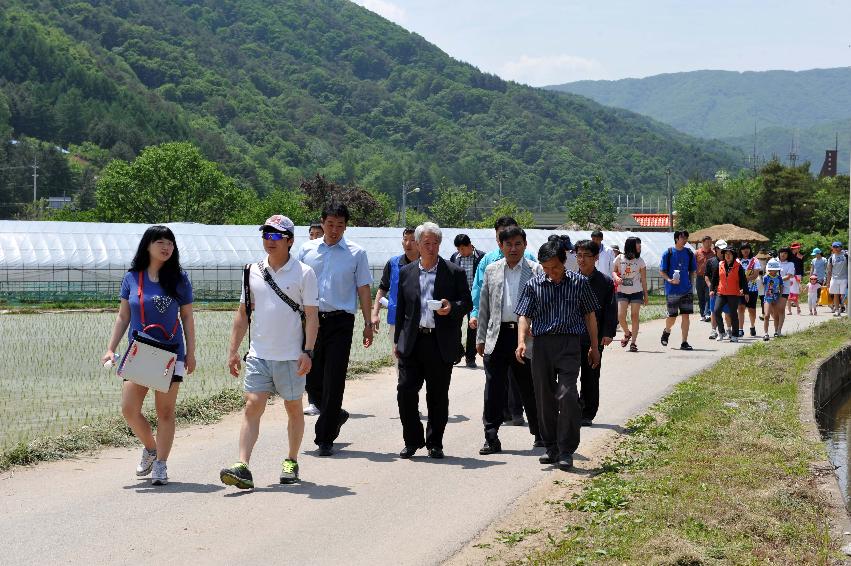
0, 0, 740, 219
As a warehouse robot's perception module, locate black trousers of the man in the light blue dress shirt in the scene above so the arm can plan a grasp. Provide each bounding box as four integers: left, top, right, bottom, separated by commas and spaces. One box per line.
305, 313, 355, 445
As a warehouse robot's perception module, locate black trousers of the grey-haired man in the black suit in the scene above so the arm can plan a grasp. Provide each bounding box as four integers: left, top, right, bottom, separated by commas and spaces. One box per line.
396, 333, 452, 448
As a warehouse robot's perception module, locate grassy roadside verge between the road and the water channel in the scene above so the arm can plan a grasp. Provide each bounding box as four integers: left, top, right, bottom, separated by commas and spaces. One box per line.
520, 321, 851, 564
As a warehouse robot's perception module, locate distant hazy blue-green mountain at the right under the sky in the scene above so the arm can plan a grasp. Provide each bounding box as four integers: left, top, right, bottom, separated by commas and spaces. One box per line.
547, 67, 851, 172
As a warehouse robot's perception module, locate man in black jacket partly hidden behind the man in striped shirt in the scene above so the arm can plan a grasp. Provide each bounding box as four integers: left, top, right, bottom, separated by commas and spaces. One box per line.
573, 240, 618, 426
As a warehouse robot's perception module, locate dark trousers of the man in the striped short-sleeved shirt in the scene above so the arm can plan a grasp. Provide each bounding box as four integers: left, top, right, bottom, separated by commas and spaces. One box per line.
532, 334, 582, 460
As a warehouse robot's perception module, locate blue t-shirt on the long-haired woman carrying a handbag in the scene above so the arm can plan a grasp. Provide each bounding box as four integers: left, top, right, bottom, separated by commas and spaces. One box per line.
120, 270, 192, 362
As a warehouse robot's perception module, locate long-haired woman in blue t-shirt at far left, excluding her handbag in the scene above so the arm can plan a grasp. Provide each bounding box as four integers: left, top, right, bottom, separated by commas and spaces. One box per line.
101, 226, 195, 485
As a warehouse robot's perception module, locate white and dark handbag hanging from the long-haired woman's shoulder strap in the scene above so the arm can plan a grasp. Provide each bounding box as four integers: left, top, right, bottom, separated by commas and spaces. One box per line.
117, 271, 179, 393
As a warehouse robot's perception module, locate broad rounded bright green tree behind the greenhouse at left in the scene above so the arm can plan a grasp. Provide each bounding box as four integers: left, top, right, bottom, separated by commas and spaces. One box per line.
95, 142, 246, 224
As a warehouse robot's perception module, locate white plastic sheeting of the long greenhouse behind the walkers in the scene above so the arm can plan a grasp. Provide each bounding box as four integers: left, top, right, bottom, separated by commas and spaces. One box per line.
0, 220, 684, 281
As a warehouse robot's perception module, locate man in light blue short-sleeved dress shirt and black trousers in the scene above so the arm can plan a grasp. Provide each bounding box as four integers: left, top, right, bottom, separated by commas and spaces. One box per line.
298, 202, 373, 456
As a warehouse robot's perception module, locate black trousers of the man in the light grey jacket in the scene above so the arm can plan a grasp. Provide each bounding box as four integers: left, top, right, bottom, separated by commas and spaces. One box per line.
482, 324, 539, 438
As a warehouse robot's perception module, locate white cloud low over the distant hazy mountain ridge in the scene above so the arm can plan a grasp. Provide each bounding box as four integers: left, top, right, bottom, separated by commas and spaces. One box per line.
498, 54, 606, 86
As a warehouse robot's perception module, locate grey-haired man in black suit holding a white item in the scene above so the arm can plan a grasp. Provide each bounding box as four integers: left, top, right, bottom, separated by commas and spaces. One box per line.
393, 222, 473, 458
